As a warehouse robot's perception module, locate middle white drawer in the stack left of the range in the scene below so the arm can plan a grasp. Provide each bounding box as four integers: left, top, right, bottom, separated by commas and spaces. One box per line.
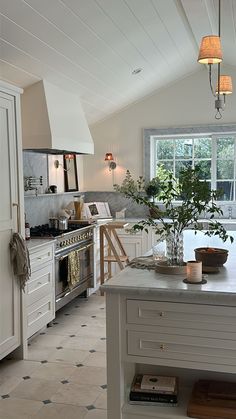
27, 263, 54, 306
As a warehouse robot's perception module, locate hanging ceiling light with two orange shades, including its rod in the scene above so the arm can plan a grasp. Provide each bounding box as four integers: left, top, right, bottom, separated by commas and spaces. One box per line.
198, 0, 233, 119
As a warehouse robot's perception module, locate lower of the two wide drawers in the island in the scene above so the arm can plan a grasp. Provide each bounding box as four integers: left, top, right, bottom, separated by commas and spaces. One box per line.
128, 331, 236, 368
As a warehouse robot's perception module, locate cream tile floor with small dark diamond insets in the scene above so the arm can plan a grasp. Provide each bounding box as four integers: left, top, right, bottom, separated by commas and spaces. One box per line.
0, 294, 107, 419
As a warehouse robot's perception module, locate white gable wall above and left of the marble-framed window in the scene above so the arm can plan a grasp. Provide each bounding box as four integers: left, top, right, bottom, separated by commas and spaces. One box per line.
83, 67, 236, 191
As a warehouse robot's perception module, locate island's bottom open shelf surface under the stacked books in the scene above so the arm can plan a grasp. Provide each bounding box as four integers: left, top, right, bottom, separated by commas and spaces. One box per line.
122, 386, 192, 419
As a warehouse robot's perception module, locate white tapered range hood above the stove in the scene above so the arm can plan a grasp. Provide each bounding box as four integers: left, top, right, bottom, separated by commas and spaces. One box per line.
21, 80, 94, 154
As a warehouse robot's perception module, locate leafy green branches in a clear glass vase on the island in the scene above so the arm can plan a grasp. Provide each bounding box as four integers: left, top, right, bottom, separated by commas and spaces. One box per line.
114, 166, 233, 265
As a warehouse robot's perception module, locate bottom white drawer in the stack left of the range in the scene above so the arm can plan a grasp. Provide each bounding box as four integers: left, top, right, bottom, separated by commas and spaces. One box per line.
27, 295, 54, 338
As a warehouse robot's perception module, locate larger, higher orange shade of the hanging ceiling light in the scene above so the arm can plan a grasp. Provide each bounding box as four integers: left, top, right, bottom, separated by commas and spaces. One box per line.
198, 35, 222, 64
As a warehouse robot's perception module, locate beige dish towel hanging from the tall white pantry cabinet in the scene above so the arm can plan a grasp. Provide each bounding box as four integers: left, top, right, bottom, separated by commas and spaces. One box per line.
10, 233, 31, 290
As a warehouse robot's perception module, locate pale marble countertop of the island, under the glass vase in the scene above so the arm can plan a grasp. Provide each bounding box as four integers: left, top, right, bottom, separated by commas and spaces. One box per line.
101, 230, 236, 305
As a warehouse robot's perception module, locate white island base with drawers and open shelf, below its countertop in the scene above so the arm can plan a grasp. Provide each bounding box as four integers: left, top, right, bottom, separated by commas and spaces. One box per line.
103, 292, 236, 419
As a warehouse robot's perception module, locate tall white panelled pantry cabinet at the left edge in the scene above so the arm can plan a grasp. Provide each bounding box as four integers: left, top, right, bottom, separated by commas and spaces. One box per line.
0, 80, 24, 359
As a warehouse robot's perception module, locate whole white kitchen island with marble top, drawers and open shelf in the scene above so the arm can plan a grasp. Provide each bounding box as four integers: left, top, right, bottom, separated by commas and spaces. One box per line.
102, 231, 236, 419
